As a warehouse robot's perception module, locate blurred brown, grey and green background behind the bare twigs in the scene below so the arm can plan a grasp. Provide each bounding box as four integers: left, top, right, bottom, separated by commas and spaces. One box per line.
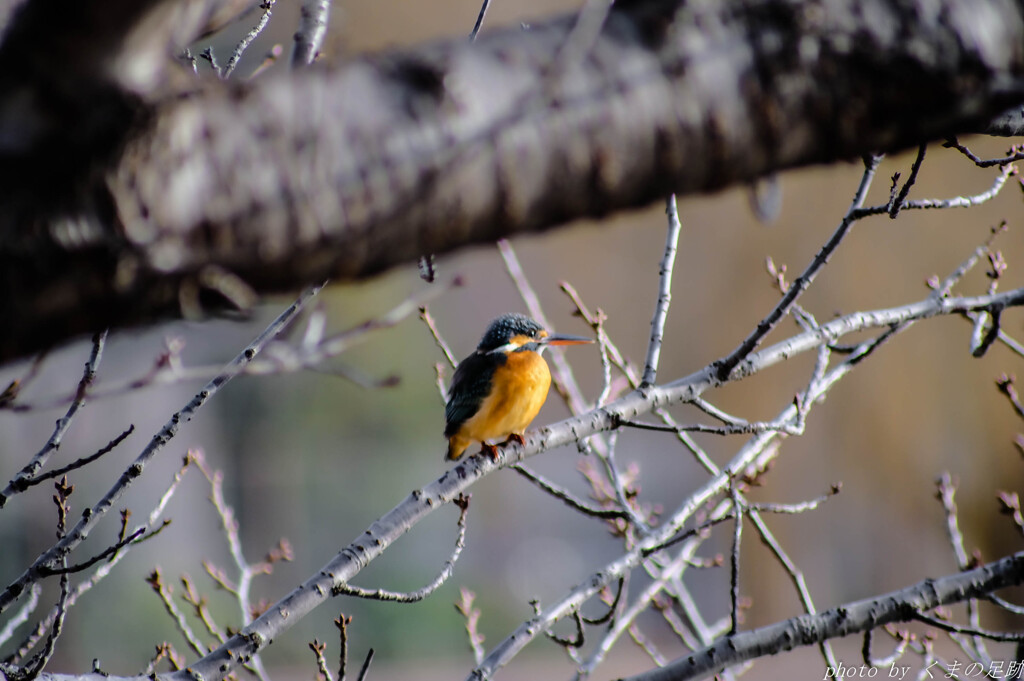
0, 0, 1024, 681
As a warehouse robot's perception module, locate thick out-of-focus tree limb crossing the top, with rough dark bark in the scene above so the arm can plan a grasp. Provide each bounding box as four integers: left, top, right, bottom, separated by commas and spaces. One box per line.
0, 0, 1024, 359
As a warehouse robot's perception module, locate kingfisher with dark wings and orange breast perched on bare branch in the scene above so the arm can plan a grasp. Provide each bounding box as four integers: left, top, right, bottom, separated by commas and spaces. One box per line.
444, 313, 594, 461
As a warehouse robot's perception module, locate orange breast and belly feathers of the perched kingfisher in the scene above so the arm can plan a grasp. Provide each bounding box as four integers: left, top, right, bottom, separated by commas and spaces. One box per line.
459, 351, 551, 442
